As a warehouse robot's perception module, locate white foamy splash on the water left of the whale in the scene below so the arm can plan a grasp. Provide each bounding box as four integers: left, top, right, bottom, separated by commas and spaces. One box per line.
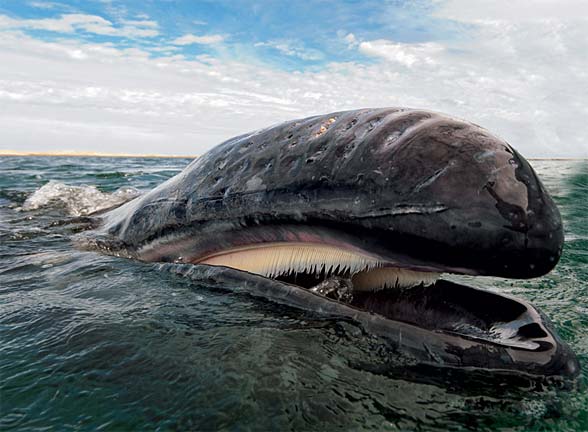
21, 180, 141, 216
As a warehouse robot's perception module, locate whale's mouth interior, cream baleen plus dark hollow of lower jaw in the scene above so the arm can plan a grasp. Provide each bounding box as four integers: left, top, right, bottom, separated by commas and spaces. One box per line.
193, 242, 553, 351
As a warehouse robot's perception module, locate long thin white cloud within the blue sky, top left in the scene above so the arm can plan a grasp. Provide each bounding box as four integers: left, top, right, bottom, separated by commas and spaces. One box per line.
0, 14, 159, 37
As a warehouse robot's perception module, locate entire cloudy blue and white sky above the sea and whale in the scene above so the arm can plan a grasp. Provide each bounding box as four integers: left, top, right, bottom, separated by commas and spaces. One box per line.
0, 0, 588, 157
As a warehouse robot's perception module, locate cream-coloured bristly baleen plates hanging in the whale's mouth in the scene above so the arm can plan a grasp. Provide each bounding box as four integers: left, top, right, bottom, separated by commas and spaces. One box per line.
193, 242, 441, 291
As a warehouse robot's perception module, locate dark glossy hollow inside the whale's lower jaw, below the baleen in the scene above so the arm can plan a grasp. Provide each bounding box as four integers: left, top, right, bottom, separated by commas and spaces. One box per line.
351, 280, 555, 351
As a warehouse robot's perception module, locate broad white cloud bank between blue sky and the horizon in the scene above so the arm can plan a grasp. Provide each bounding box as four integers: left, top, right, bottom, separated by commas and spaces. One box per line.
0, 4, 588, 157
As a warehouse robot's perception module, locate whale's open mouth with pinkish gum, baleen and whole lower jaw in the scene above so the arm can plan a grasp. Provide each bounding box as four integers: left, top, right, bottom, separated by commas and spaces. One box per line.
140, 225, 577, 376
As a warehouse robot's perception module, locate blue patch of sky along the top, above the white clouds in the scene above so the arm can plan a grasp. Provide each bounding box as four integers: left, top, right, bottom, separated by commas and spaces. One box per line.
0, 0, 466, 71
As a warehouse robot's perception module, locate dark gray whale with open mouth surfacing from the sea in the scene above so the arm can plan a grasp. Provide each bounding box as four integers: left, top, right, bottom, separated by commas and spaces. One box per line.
82, 108, 579, 377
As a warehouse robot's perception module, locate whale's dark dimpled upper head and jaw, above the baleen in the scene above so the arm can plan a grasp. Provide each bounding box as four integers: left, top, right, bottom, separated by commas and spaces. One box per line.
97, 108, 563, 278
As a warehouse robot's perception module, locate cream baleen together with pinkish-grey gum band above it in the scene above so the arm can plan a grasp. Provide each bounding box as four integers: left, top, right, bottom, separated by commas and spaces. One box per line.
137, 223, 454, 298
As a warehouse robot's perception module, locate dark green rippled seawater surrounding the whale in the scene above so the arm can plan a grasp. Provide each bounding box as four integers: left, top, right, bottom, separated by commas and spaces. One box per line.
0, 157, 588, 431
